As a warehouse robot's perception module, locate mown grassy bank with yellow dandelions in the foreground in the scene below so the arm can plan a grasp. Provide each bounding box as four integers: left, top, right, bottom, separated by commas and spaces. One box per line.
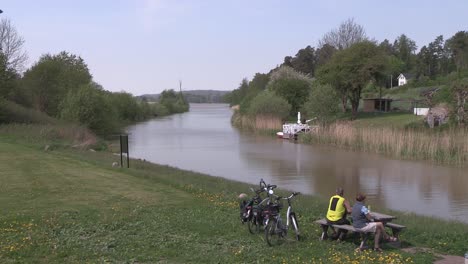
0, 125, 468, 263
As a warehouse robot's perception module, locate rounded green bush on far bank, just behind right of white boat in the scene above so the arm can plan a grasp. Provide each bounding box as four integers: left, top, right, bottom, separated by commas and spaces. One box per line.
304, 84, 340, 123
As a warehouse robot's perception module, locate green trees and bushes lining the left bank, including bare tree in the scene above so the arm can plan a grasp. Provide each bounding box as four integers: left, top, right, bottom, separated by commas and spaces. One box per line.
0, 19, 189, 134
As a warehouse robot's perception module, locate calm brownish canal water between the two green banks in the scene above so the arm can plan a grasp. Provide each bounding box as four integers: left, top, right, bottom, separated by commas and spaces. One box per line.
128, 104, 468, 223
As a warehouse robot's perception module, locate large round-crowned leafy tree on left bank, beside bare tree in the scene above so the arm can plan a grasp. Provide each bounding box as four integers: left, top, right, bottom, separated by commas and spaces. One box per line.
23, 51, 92, 116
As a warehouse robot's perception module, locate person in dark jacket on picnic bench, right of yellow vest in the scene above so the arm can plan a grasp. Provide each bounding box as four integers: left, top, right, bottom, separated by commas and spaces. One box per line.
351, 193, 397, 252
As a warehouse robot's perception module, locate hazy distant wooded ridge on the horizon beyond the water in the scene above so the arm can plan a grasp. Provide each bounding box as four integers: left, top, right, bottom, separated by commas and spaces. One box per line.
138, 90, 228, 103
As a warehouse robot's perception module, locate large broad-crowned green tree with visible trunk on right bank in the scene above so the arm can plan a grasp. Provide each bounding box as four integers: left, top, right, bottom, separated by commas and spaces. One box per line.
319, 41, 388, 118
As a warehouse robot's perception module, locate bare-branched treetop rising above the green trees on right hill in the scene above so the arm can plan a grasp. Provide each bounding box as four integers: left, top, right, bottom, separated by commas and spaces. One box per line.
319, 18, 367, 50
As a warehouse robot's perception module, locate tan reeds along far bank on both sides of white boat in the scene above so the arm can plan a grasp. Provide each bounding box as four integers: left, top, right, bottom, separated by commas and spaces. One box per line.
231, 108, 468, 167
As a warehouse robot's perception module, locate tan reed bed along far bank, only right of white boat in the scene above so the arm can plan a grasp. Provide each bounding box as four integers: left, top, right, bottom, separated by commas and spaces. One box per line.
301, 123, 468, 165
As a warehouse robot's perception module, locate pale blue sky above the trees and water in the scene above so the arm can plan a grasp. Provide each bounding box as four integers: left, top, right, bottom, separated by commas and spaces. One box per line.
0, 0, 468, 95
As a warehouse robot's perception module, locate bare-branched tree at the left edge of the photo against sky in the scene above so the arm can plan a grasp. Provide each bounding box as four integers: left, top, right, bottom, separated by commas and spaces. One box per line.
0, 19, 28, 73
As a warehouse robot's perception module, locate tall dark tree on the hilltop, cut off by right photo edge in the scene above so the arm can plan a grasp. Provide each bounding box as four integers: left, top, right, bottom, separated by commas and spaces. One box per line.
447, 31, 468, 72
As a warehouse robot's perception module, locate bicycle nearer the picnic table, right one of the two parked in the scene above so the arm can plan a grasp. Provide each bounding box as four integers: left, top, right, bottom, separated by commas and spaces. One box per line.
265, 192, 300, 246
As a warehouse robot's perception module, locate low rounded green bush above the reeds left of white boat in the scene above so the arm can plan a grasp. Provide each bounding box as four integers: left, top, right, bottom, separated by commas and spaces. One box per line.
248, 90, 291, 120
